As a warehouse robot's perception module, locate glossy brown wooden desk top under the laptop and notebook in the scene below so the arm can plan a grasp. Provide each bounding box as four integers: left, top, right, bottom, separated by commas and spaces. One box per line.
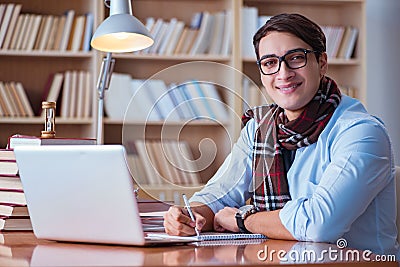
0, 232, 398, 266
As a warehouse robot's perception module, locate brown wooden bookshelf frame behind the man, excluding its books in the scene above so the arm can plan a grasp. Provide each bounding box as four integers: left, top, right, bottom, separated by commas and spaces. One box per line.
0, 0, 367, 201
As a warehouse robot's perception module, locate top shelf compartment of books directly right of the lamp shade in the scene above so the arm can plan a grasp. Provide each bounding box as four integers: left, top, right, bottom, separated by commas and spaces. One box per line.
128, 0, 234, 56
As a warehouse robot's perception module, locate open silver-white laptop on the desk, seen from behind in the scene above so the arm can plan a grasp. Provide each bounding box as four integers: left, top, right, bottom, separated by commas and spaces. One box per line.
14, 145, 192, 245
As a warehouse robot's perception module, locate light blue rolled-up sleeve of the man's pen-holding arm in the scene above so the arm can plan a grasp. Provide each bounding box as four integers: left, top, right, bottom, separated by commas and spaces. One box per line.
190, 120, 255, 213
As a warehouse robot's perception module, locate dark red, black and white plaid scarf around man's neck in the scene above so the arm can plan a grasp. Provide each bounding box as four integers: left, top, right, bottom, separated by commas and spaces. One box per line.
242, 77, 341, 211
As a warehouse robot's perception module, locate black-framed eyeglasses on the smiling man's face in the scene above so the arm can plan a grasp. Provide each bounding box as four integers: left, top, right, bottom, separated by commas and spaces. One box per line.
257, 48, 318, 75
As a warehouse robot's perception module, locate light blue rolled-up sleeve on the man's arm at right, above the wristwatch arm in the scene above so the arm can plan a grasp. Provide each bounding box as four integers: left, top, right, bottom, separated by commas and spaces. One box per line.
279, 120, 393, 242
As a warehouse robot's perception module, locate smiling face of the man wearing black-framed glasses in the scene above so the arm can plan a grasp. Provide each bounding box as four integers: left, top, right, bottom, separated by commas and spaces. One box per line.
259, 32, 327, 120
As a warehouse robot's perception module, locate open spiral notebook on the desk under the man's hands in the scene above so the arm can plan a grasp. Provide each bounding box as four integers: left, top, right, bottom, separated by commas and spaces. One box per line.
147, 232, 267, 242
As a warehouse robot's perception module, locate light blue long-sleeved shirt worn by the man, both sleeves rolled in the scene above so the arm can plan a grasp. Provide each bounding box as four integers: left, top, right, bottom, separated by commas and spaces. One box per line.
191, 95, 398, 254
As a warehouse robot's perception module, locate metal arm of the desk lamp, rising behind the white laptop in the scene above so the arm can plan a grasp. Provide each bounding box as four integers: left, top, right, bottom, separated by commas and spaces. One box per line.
96, 52, 115, 145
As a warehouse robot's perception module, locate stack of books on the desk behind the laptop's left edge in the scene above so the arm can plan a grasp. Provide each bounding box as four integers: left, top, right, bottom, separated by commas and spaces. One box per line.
0, 149, 32, 231
